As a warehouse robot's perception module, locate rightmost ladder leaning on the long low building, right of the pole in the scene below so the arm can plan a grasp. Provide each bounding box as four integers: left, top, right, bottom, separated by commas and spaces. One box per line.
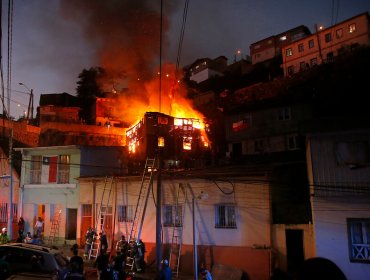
169, 184, 187, 278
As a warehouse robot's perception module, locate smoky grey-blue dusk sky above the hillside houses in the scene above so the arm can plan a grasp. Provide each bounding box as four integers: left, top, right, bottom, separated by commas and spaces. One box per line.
2, 0, 370, 118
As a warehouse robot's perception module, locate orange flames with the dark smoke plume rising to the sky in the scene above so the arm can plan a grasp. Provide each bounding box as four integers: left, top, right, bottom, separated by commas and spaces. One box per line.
60, 0, 208, 158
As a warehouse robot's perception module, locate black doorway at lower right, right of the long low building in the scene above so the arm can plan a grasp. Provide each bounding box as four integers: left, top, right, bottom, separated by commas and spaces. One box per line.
285, 229, 304, 274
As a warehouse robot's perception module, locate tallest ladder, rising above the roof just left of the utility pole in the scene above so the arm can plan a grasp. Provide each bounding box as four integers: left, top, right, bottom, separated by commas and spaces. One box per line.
126, 158, 155, 270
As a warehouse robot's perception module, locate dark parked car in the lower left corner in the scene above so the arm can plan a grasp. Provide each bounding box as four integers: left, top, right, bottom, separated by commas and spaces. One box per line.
0, 243, 68, 280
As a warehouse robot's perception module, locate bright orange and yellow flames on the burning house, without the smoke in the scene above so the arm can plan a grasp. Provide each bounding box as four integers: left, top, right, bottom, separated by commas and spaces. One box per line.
121, 65, 209, 156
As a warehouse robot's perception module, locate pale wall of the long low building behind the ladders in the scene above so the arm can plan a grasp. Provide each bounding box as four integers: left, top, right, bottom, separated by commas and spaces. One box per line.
79, 177, 270, 247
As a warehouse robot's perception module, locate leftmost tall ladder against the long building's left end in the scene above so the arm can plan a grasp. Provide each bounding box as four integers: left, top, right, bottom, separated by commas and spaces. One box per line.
89, 177, 114, 259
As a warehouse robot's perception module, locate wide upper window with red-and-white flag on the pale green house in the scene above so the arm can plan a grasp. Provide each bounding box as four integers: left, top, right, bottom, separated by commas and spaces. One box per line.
30, 155, 70, 184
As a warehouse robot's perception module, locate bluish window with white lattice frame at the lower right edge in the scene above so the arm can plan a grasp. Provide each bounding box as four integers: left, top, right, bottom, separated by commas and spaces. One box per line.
347, 219, 370, 263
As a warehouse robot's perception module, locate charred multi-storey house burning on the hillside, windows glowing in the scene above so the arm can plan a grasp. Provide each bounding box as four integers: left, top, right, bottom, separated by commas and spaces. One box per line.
126, 112, 210, 168
